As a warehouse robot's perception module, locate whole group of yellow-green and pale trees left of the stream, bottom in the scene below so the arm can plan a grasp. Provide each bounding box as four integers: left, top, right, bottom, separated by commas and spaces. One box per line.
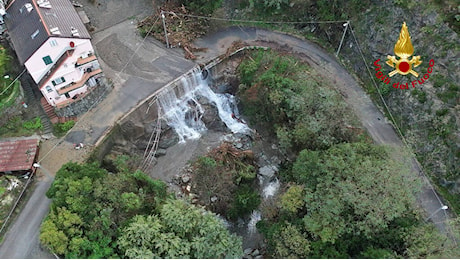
40, 159, 242, 258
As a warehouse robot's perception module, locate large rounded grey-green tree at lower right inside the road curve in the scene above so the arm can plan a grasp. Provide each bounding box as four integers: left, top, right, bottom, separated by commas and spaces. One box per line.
292, 143, 418, 242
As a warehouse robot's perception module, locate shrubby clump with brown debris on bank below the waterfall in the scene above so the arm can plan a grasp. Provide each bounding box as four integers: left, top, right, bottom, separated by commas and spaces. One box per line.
192, 143, 260, 219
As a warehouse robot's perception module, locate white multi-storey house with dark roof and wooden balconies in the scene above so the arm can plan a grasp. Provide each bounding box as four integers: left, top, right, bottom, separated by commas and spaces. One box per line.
4, 0, 102, 108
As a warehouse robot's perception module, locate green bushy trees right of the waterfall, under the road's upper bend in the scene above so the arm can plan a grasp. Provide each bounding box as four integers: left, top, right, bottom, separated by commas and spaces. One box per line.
238, 51, 356, 152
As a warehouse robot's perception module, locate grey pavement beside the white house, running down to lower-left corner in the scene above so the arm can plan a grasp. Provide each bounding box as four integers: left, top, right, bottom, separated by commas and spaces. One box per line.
0, 3, 195, 258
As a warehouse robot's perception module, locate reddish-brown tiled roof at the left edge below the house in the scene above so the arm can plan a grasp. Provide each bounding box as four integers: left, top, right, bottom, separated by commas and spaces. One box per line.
0, 139, 39, 172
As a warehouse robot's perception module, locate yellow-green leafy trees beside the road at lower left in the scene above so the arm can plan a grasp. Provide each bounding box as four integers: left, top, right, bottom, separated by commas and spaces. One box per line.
40, 163, 167, 258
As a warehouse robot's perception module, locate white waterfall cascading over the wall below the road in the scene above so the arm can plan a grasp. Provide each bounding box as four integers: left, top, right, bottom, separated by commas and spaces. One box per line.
158, 69, 249, 142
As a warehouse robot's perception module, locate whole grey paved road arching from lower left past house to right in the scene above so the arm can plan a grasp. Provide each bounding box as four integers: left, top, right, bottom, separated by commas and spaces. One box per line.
0, 24, 454, 258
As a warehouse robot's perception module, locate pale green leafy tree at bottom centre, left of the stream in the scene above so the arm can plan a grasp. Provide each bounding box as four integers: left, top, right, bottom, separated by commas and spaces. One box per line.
118, 200, 242, 258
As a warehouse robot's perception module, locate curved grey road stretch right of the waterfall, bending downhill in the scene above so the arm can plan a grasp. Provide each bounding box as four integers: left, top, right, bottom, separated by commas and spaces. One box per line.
195, 26, 450, 234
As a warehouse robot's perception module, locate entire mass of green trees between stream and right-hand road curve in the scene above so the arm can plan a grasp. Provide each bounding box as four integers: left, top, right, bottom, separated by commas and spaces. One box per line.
238, 52, 460, 258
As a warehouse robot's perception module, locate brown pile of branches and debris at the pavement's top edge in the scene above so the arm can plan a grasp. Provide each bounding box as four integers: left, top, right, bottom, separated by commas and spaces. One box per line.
137, 1, 209, 60
